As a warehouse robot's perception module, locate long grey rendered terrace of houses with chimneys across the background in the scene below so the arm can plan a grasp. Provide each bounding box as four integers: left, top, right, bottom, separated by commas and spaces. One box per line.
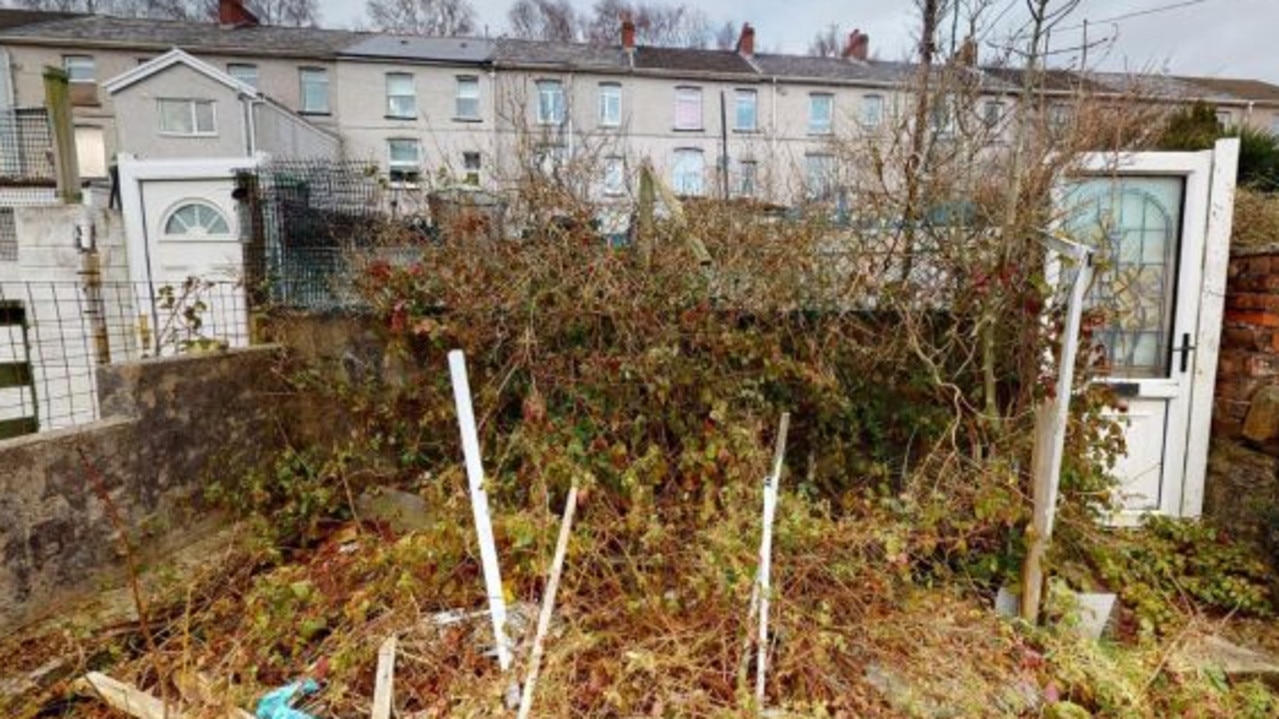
0, 0, 1279, 202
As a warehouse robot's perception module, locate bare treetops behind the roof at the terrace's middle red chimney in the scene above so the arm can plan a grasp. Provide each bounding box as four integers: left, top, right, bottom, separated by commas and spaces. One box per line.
582, 0, 714, 49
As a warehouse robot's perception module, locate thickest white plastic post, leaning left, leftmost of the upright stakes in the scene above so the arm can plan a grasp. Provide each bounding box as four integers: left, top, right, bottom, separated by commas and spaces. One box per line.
449, 349, 510, 672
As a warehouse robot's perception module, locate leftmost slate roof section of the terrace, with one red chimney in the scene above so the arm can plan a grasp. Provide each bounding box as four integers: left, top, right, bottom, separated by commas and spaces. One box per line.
0, 15, 368, 59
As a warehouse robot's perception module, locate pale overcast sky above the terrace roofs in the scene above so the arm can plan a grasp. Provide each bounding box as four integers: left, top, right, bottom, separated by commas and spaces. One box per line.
320, 0, 1279, 83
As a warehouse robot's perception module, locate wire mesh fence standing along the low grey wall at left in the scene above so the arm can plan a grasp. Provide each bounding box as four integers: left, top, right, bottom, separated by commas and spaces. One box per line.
0, 279, 249, 439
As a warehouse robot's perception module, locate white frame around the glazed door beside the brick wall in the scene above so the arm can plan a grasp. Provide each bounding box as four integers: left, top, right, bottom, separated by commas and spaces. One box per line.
1081, 138, 1239, 523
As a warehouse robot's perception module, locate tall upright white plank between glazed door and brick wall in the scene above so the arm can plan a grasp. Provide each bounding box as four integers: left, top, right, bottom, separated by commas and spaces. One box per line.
1181, 138, 1239, 517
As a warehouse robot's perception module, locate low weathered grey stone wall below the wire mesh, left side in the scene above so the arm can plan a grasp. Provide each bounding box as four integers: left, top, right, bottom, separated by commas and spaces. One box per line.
0, 347, 285, 631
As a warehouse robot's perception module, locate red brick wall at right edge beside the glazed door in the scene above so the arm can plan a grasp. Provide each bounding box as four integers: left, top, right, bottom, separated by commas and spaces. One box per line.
1212, 246, 1279, 439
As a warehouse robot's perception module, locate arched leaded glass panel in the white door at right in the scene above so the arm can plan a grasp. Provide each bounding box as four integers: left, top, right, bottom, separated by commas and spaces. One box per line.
1065, 177, 1184, 379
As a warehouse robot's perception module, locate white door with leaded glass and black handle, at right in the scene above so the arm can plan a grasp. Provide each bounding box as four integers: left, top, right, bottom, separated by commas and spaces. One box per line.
1064, 151, 1212, 516
